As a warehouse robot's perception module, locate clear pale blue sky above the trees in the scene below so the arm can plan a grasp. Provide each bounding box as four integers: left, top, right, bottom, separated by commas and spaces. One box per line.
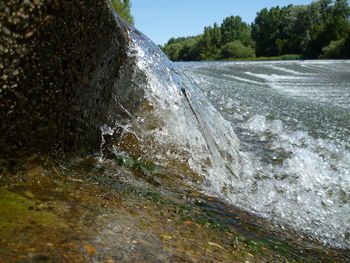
131, 0, 312, 44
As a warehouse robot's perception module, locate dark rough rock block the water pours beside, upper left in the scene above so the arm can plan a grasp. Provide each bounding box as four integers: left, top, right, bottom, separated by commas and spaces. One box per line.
0, 0, 138, 157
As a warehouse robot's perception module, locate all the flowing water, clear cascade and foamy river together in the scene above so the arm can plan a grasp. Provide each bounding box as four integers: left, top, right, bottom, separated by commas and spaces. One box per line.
106, 23, 350, 251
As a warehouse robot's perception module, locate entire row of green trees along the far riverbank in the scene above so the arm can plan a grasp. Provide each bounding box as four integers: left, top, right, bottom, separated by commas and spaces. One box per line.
161, 0, 350, 61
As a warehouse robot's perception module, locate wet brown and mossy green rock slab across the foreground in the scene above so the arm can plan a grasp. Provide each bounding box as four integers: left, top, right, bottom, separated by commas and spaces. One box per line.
0, 158, 349, 263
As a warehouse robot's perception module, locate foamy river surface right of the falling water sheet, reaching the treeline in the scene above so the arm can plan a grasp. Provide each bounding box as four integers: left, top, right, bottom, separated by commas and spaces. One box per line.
178, 61, 350, 252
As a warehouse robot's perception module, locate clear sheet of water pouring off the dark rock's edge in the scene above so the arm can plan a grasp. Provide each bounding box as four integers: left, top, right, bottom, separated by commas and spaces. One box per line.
106, 25, 242, 193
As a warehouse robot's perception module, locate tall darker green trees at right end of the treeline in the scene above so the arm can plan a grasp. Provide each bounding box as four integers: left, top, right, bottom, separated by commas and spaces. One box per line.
252, 0, 350, 58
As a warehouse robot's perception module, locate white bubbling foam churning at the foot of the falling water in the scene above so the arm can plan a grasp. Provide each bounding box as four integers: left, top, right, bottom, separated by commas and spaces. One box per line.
233, 115, 350, 247
